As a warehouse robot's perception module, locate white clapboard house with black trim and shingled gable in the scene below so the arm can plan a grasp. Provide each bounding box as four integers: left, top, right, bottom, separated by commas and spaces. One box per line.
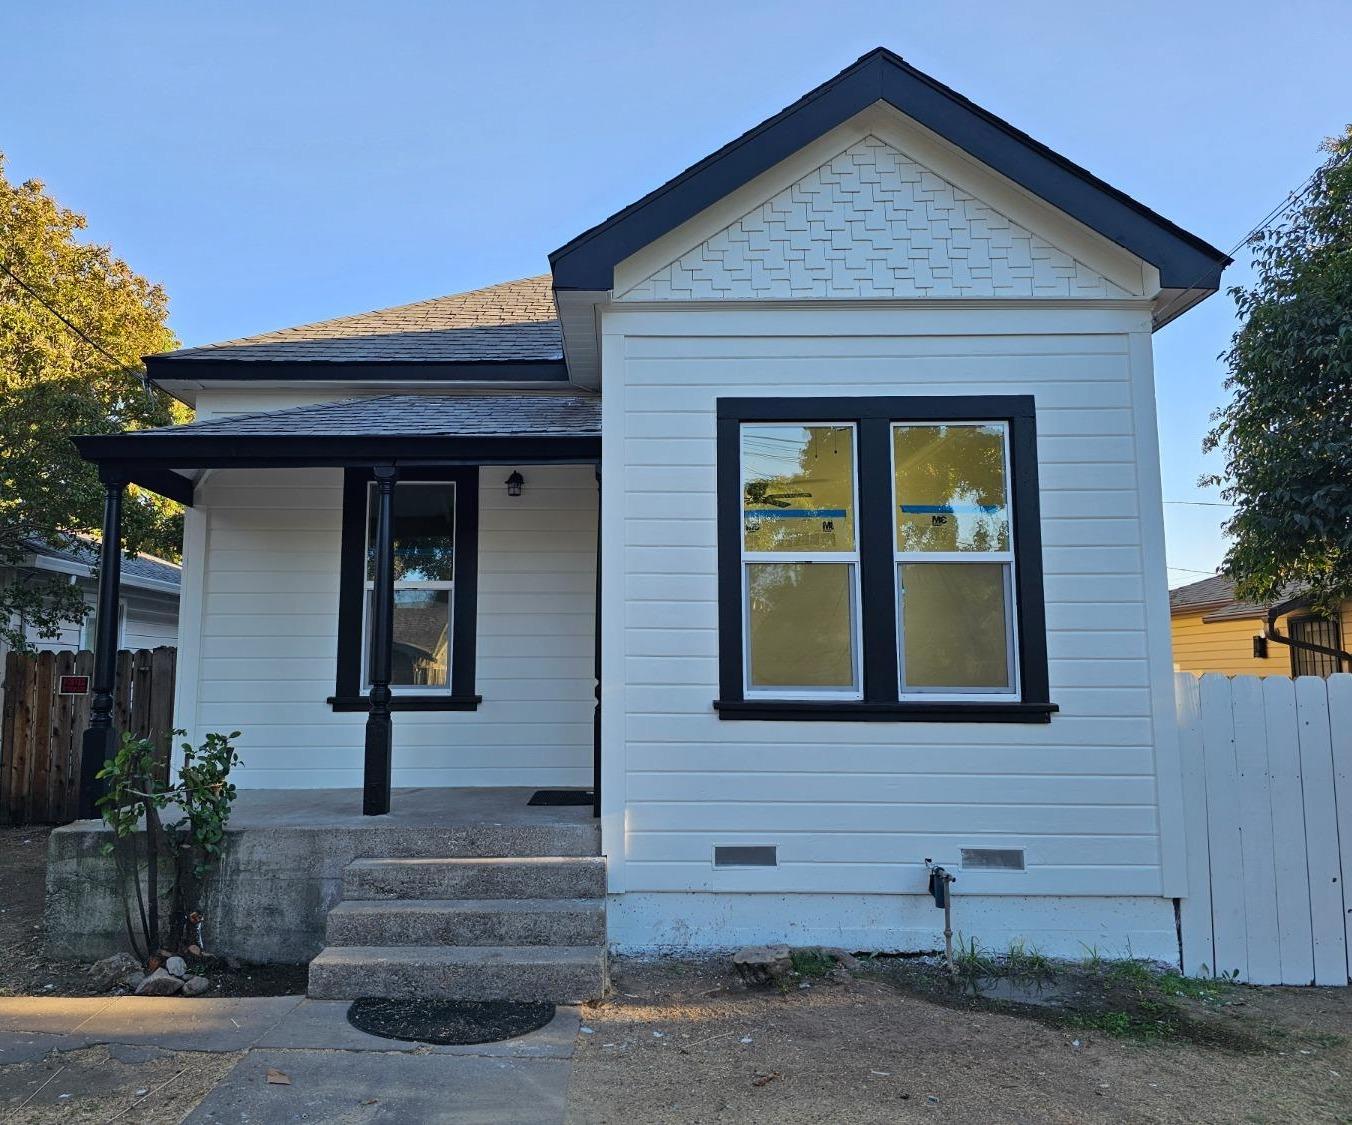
65, 50, 1228, 989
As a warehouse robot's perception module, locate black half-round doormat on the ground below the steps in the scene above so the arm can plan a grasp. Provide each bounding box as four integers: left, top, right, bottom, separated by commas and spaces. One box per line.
347, 998, 554, 1047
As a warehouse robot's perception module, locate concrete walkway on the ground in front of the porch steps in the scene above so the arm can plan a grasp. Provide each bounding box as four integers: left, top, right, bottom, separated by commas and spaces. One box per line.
0, 997, 579, 1125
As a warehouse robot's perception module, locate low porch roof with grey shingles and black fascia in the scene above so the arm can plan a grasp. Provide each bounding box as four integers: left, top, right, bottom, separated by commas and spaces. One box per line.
74, 389, 600, 504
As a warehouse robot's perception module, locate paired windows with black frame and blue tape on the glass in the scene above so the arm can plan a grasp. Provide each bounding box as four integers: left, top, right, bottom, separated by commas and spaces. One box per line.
715, 396, 1056, 722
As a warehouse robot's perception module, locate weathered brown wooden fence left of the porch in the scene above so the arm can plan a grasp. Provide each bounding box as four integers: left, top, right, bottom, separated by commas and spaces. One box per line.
0, 648, 177, 825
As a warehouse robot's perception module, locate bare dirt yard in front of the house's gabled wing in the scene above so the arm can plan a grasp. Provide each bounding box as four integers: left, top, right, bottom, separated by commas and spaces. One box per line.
568, 959, 1352, 1125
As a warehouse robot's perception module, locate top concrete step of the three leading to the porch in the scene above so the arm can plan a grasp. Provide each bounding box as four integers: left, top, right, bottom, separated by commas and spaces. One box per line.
342, 856, 606, 899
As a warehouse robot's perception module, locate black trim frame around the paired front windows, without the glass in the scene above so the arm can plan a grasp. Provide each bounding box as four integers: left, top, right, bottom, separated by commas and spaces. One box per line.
714, 395, 1057, 723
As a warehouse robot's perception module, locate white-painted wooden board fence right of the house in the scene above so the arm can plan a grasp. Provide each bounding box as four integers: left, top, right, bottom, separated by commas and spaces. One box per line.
1175, 673, 1352, 984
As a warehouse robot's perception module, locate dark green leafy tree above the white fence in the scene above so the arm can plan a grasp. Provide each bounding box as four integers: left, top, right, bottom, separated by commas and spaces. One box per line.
1203, 126, 1352, 611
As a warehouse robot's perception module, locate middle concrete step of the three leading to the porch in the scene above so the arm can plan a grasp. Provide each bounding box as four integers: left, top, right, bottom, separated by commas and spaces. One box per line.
326, 898, 606, 945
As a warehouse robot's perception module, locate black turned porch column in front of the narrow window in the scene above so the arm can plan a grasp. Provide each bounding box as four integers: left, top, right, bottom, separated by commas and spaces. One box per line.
361, 465, 399, 817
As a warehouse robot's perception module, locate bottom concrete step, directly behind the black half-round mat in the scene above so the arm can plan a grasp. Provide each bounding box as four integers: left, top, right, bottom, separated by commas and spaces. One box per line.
310, 945, 606, 1003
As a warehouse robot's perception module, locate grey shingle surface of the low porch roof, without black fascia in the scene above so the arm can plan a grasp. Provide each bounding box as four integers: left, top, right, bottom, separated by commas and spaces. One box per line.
135, 389, 600, 441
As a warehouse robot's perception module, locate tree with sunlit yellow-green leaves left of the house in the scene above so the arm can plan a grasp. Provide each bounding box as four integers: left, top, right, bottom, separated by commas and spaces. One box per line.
0, 155, 187, 648
